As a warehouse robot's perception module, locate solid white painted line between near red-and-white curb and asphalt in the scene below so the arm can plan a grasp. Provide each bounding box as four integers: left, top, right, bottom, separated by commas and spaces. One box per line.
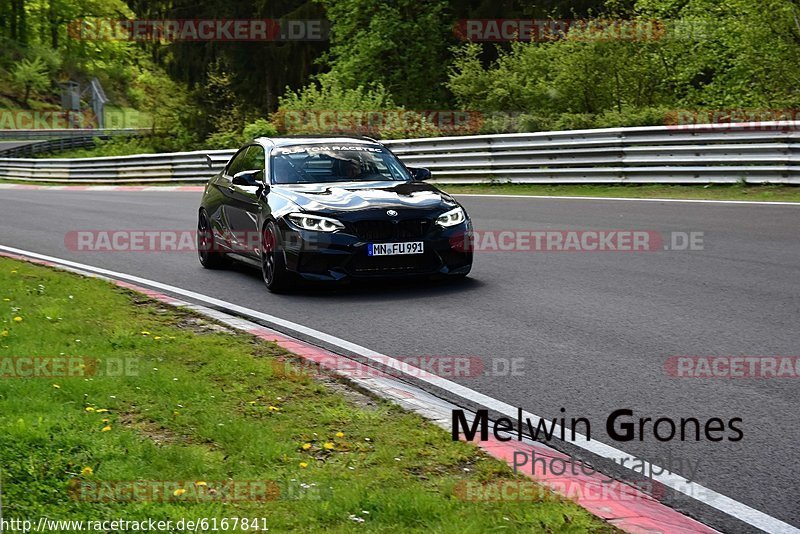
0, 245, 800, 534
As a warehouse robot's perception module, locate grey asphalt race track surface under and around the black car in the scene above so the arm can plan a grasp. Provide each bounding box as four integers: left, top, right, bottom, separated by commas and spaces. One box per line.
0, 190, 800, 532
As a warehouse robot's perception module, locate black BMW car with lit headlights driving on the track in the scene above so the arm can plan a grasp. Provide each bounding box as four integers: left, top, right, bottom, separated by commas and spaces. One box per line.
197, 137, 472, 291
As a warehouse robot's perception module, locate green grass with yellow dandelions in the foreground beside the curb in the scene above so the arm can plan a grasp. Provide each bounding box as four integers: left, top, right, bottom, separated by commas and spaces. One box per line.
0, 258, 614, 533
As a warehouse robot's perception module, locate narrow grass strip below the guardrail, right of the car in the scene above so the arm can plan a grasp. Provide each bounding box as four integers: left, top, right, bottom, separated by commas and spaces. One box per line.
441, 184, 800, 202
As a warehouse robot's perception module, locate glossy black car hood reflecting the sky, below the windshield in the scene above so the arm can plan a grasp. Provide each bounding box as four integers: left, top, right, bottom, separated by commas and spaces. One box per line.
273, 182, 457, 212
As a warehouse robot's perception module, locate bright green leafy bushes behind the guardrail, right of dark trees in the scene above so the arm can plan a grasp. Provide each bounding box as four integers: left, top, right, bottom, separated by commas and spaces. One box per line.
448, 0, 800, 129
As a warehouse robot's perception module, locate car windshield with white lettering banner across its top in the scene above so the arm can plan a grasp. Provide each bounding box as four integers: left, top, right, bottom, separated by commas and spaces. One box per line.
271, 144, 411, 184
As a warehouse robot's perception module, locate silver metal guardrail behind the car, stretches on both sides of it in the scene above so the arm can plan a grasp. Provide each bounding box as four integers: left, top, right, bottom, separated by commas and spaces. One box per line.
0, 122, 800, 184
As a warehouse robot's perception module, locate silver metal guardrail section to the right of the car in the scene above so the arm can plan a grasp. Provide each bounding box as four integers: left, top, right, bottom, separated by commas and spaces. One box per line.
387, 122, 800, 184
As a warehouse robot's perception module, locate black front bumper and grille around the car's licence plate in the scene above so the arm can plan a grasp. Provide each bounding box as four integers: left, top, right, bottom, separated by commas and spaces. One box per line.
279, 220, 472, 281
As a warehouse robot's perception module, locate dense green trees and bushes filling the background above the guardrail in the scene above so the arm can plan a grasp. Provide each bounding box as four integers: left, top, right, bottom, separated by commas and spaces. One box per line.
0, 0, 800, 146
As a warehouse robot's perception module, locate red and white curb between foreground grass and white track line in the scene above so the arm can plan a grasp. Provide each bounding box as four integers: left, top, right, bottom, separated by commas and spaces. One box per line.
0, 251, 717, 534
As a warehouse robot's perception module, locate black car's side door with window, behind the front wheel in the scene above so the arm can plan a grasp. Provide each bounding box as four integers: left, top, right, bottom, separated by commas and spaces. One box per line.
227, 145, 266, 258
